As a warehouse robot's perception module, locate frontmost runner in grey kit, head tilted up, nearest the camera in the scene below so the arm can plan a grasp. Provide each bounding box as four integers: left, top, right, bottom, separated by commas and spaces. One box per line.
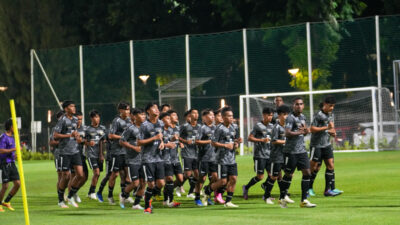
138, 103, 165, 214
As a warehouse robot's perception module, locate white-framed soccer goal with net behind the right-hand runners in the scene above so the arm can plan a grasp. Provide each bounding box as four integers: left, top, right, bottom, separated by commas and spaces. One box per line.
239, 87, 399, 155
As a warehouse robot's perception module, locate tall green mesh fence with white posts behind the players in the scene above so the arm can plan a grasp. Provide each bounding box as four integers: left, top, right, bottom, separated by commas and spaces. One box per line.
31, 16, 400, 150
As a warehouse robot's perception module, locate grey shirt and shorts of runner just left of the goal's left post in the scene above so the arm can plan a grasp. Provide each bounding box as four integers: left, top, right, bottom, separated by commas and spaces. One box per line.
213, 124, 239, 165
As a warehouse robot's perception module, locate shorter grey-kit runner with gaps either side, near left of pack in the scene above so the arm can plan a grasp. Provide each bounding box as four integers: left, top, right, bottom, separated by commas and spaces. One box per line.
85, 110, 106, 200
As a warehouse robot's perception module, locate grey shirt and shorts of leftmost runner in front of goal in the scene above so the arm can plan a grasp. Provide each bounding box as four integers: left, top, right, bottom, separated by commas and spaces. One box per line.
250, 122, 274, 159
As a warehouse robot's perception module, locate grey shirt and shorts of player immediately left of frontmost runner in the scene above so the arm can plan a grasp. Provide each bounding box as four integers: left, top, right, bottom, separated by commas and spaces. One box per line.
120, 124, 142, 165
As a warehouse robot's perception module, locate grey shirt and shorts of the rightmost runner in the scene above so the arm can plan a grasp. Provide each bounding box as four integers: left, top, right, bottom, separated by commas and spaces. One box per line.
310, 111, 333, 148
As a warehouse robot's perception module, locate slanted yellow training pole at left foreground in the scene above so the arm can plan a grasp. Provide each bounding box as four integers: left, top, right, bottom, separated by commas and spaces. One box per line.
10, 99, 29, 225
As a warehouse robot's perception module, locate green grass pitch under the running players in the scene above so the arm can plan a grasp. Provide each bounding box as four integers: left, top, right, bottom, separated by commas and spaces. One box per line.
0, 151, 400, 225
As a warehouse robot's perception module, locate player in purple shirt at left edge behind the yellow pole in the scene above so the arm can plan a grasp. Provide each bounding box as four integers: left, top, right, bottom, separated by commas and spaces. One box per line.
0, 119, 21, 212
